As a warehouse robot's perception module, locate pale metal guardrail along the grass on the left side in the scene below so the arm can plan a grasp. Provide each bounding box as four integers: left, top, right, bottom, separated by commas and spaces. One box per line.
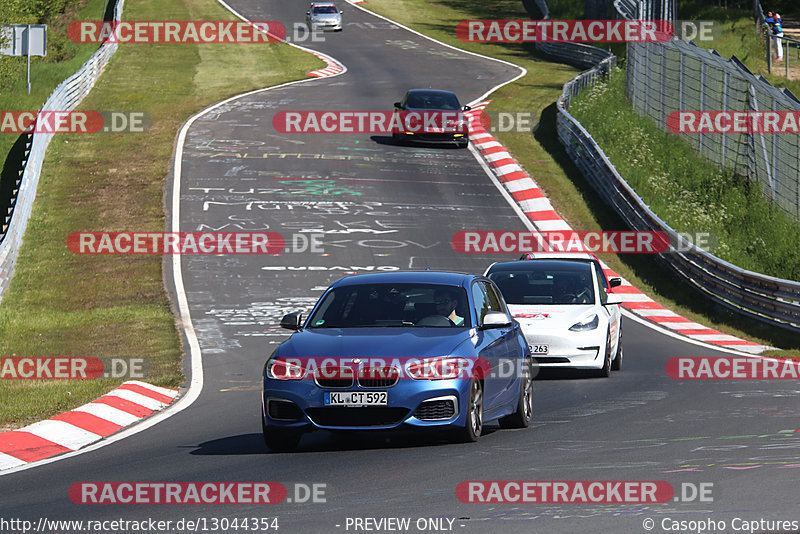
0, 0, 124, 300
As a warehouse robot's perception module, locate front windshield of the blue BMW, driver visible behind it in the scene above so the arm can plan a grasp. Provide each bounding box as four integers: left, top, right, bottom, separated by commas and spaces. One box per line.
308, 284, 469, 328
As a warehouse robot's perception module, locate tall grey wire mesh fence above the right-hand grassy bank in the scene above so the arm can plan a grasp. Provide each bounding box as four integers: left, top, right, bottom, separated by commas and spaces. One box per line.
620, 0, 800, 220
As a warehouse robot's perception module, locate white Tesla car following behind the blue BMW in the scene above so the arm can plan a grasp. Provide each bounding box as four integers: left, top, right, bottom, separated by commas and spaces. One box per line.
486, 253, 622, 376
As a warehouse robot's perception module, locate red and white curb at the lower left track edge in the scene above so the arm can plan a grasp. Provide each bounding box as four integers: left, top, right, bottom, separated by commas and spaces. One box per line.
0, 380, 178, 470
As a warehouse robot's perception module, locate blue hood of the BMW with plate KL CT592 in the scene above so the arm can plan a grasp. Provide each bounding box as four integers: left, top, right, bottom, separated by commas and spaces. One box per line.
274, 328, 472, 358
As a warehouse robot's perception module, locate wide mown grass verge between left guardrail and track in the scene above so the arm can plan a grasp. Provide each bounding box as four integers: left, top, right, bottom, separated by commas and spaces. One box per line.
0, 0, 324, 428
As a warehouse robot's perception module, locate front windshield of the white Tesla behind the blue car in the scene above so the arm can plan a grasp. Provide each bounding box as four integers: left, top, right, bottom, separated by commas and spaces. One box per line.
487, 261, 595, 305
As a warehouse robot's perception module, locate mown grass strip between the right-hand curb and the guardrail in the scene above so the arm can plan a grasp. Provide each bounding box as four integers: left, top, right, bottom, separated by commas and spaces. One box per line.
364, 0, 800, 356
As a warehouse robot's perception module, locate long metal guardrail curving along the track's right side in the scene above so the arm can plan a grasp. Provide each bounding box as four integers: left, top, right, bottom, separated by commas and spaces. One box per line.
524, 0, 800, 332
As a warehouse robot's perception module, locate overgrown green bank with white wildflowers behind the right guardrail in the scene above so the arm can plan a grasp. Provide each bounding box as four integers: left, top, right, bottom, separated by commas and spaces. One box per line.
570, 70, 800, 280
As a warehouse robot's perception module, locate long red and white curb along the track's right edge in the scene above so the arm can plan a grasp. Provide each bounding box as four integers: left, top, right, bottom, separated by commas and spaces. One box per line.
465, 100, 772, 354
